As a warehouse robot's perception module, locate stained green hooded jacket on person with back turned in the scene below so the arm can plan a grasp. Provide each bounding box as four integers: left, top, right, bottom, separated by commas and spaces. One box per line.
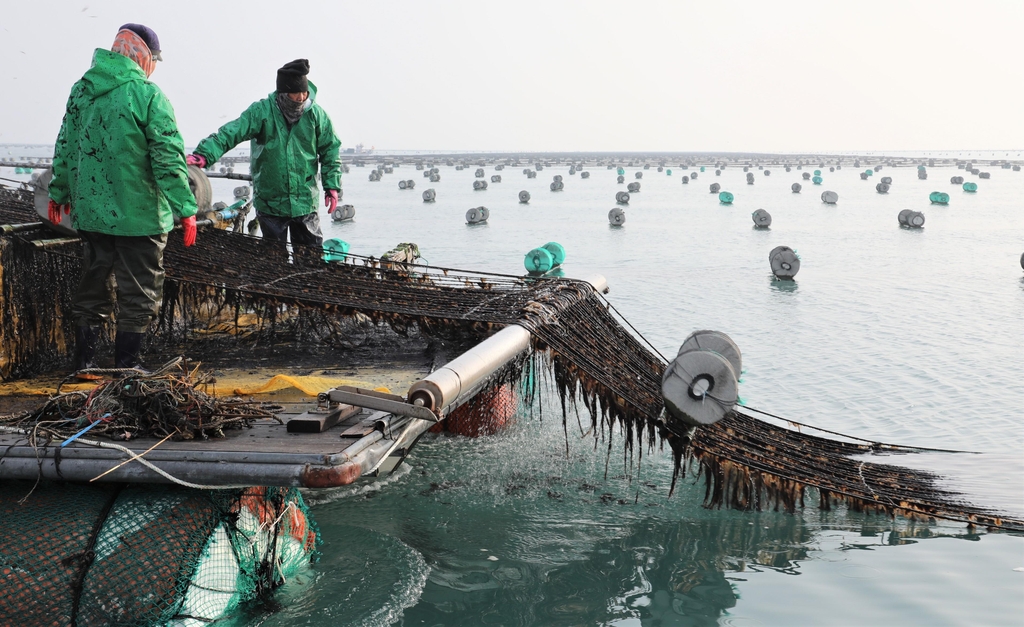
49, 49, 196, 236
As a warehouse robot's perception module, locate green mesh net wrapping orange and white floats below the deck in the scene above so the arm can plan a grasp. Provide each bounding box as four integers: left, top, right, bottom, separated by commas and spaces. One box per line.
0, 482, 318, 627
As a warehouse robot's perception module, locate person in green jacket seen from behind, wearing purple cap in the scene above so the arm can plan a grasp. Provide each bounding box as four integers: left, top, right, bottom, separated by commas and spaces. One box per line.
49, 24, 196, 378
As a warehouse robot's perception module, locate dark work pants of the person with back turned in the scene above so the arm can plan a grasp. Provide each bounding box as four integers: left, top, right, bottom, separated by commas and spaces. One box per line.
72, 231, 167, 333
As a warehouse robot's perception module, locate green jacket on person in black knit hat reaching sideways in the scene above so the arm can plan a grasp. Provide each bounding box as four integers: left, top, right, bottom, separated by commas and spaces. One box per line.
196, 83, 341, 217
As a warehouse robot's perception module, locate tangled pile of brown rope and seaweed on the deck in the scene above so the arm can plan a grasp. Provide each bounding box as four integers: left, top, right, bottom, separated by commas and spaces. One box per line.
0, 363, 281, 446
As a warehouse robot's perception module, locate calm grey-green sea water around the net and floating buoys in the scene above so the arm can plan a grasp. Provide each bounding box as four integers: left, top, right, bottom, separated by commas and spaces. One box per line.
0, 152, 1024, 626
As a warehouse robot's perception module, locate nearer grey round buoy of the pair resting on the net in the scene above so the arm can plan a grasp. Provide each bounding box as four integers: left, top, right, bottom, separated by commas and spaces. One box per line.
662, 350, 739, 427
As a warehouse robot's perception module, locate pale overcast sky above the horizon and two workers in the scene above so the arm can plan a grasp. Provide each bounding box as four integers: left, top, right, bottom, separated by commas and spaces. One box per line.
0, 0, 1024, 152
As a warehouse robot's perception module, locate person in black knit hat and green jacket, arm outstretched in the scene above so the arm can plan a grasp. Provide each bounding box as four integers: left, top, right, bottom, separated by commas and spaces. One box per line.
187, 58, 341, 256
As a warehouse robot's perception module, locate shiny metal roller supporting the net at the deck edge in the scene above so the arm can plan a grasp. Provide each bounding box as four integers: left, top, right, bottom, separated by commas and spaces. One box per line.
408, 275, 608, 415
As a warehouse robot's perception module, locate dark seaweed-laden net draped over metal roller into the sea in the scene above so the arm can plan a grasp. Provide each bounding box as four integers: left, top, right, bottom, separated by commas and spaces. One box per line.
2, 204, 1024, 530
